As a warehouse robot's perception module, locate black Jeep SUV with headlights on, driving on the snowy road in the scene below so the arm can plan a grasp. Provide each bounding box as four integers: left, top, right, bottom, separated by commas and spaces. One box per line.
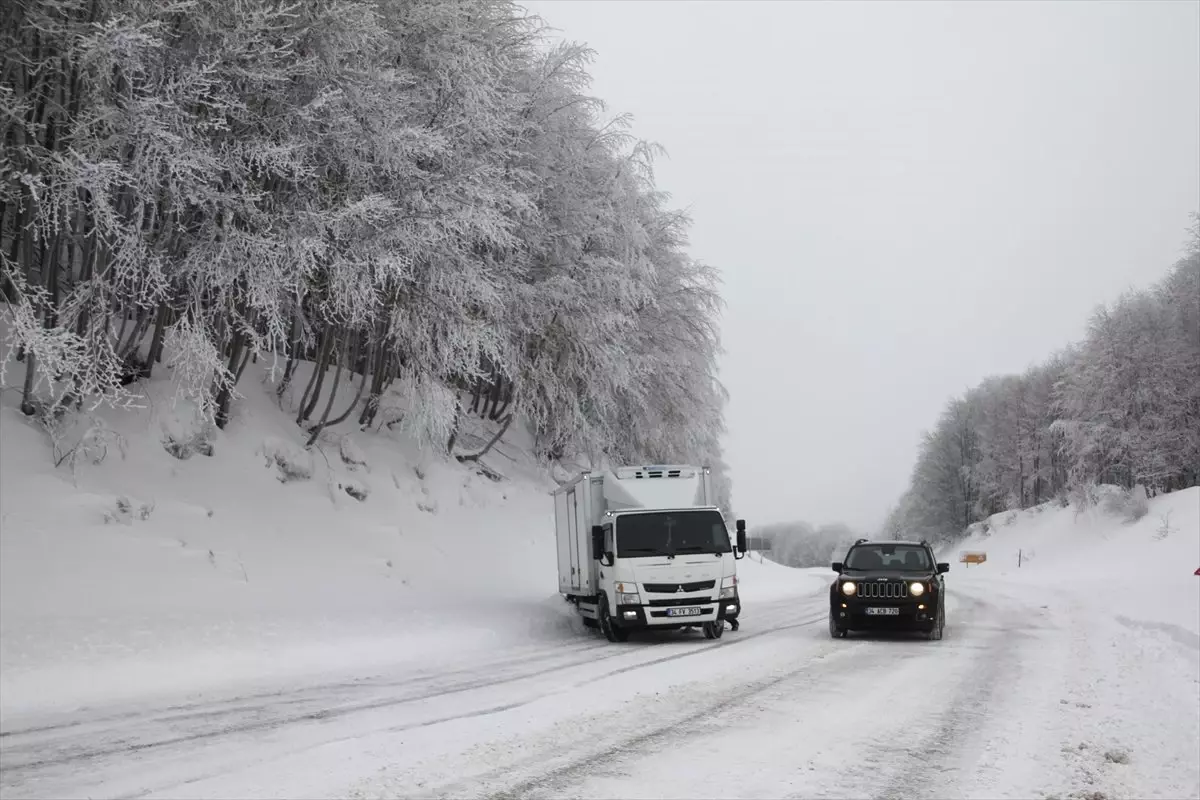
829, 539, 950, 639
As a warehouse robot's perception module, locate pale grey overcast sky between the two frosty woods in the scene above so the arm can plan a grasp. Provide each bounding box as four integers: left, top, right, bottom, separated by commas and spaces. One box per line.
522, 0, 1200, 530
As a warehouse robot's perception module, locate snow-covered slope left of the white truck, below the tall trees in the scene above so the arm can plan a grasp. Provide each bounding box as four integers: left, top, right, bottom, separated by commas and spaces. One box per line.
0, 363, 801, 721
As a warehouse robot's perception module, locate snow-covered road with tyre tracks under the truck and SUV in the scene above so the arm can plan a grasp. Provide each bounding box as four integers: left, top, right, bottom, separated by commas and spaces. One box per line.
0, 581, 1200, 798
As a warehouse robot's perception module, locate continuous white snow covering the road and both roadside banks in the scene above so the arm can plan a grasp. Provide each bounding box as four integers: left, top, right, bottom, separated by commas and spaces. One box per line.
0, 364, 1200, 798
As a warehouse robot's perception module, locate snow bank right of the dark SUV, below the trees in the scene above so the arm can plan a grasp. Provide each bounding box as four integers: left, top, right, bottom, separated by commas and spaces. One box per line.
942, 487, 1200, 649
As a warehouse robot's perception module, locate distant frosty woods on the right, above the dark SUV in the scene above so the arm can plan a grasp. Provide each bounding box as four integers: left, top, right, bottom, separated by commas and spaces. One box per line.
884, 216, 1200, 542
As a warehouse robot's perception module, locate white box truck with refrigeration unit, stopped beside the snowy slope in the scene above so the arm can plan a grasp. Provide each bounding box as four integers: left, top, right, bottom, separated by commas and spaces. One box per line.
554, 465, 746, 642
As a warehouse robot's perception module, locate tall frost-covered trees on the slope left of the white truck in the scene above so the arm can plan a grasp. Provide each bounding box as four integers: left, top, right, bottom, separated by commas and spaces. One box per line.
0, 0, 725, 491
